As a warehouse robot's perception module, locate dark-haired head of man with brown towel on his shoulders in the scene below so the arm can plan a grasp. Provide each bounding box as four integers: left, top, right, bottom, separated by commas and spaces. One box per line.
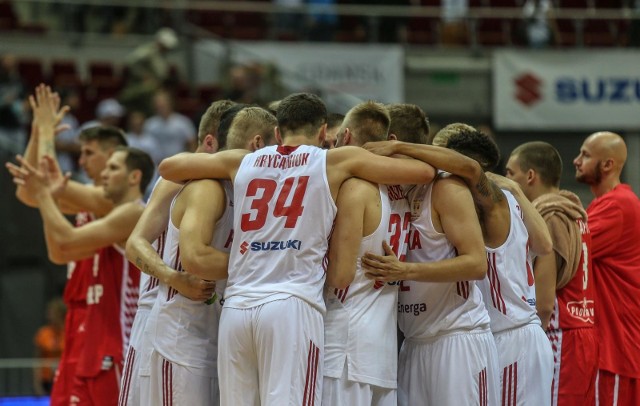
511, 141, 562, 187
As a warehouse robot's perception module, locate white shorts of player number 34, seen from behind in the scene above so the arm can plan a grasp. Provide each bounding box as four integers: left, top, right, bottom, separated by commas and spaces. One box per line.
218, 296, 324, 406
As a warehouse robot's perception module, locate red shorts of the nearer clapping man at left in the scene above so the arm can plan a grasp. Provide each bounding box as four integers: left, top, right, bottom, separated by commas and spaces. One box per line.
69, 363, 122, 406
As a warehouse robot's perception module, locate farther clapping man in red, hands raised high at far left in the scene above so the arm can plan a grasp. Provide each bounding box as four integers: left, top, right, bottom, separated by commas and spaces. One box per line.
10, 85, 126, 406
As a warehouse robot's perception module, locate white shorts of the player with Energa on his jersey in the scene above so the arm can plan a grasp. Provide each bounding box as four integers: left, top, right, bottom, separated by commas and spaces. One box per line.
398, 329, 499, 406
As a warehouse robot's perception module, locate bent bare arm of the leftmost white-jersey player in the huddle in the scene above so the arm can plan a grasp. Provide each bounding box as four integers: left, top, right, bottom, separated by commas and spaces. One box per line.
126, 179, 215, 301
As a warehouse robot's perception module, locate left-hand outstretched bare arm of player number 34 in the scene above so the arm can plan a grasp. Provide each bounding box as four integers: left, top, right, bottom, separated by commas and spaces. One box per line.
158, 149, 250, 183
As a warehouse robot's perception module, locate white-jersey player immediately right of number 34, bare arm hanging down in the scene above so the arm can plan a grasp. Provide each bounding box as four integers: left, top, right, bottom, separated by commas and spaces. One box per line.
322, 102, 409, 406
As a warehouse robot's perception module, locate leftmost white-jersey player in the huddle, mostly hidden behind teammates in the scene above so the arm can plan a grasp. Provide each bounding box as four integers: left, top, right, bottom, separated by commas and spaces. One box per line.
119, 100, 234, 406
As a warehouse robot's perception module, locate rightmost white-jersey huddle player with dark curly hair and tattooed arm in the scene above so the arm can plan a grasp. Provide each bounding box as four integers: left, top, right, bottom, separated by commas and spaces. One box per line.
364, 125, 553, 405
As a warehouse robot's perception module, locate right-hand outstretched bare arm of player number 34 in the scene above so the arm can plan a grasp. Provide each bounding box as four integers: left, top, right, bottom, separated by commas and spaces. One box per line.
327, 146, 436, 199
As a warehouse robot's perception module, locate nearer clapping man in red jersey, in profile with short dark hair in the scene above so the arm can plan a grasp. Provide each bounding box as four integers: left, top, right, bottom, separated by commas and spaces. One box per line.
14, 147, 153, 405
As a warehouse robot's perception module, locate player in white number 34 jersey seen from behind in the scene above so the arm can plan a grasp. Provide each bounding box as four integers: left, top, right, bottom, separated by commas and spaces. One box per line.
160, 93, 433, 405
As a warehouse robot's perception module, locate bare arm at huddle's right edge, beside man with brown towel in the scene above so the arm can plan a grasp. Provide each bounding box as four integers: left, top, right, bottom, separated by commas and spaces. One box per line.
487, 173, 553, 255
